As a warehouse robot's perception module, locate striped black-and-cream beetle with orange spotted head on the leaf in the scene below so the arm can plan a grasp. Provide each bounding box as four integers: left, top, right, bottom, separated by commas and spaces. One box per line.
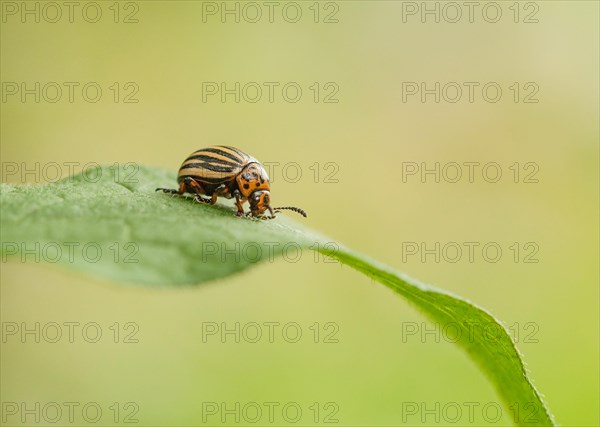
156, 145, 307, 219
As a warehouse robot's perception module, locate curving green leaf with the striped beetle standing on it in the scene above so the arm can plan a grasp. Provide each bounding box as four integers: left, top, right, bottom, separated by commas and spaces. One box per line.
0, 167, 554, 425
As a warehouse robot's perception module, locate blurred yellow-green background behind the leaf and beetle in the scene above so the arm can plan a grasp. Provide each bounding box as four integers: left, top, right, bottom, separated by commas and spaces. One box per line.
0, 1, 600, 426
